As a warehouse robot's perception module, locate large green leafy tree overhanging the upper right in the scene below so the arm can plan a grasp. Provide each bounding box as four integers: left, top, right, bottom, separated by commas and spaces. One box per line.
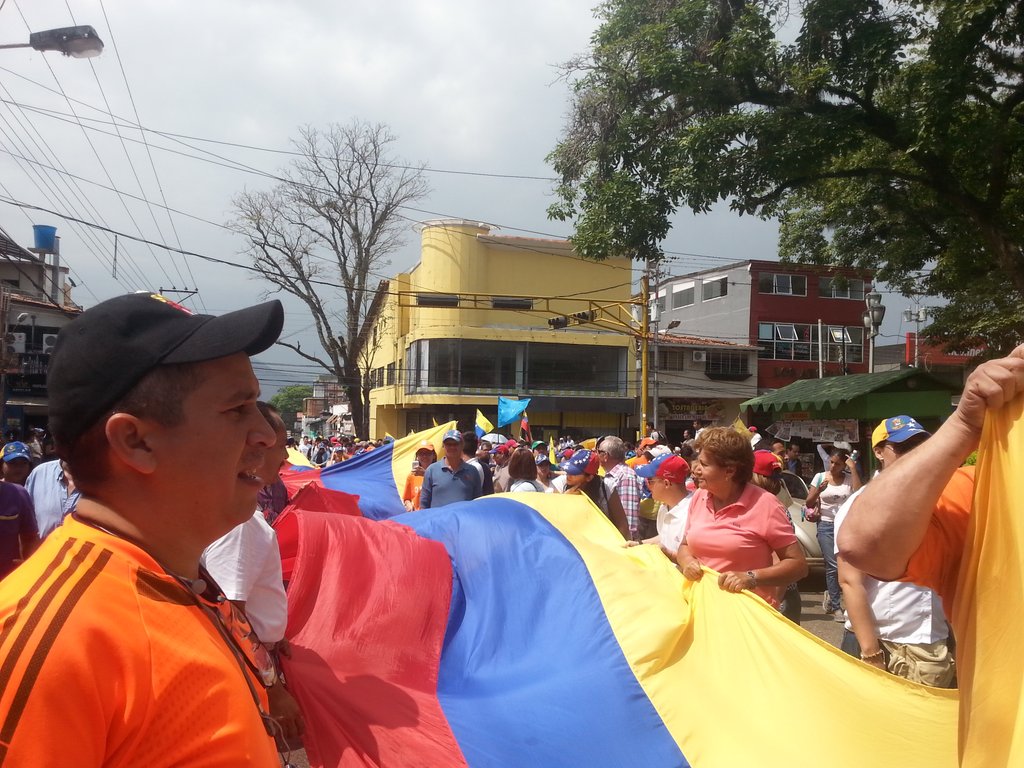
549, 0, 1024, 351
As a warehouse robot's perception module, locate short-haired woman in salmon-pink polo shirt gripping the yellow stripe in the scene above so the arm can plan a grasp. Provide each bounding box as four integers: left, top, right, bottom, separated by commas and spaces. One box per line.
676, 427, 807, 608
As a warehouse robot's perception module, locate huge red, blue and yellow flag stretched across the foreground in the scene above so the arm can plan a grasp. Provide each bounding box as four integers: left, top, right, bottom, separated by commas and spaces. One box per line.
287, 494, 956, 768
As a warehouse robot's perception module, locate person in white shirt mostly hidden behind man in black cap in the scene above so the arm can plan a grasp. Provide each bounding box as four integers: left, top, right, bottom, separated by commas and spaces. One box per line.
203, 402, 305, 740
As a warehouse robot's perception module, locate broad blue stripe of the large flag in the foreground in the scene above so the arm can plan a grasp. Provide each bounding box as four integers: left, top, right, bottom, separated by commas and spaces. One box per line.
395, 495, 689, 766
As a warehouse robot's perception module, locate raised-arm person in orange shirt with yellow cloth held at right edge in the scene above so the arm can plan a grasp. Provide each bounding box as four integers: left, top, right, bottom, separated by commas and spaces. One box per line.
838, 345, 1024, 766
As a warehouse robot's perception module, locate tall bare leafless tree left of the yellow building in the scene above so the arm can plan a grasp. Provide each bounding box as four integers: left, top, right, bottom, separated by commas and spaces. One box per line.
233, 121, 428, 435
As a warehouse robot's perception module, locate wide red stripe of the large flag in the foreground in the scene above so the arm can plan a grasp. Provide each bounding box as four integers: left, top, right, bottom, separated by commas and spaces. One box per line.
278, 512, 466, 768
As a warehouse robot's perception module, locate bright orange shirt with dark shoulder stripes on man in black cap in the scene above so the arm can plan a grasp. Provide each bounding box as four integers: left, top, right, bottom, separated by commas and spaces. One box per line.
0, 517, 280, 768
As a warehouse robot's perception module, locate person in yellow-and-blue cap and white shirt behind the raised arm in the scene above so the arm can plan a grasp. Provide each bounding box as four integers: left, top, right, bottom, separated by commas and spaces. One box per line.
836, 417, 955, 688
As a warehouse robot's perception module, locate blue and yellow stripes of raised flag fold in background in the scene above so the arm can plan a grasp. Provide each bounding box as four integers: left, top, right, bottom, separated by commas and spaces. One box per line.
319, 421, 456, 520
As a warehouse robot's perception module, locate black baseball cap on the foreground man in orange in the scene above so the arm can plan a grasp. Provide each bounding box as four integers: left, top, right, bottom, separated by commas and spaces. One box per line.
46, 293, 285, 445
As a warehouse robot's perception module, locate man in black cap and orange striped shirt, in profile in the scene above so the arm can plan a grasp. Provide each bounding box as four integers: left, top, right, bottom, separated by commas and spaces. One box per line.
0, 294, 284, 767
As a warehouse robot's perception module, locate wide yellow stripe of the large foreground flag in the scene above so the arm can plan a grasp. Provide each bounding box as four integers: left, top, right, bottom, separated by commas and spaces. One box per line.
520, 494, 958, 768
